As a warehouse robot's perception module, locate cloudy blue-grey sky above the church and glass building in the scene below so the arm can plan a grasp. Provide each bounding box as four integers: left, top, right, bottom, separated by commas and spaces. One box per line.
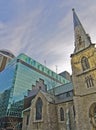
0, 0, 96, 73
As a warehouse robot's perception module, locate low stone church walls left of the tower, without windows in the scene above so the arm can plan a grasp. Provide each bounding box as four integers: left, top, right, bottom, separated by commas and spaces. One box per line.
22, 92, 75, 130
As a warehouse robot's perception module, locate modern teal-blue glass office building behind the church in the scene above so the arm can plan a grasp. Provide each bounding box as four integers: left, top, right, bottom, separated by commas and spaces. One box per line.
0, 54, 69, 117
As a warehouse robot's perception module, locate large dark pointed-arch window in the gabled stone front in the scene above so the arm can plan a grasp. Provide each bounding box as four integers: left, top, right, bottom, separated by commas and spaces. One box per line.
36, 97, 43, 120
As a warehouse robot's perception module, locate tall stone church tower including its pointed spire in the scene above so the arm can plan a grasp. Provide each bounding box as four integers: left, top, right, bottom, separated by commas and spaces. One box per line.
71, 9, 96, 130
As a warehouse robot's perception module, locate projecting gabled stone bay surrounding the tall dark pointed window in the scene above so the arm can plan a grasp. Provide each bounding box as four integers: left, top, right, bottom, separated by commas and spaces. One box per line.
28, 93, 58, 130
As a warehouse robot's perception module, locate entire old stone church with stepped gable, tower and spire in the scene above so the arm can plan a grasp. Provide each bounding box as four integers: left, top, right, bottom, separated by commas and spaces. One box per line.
22, 9, 96, 130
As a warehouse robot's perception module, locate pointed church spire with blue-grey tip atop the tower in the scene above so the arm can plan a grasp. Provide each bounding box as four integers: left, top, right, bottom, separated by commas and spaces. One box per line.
72, 9, 91, 52
